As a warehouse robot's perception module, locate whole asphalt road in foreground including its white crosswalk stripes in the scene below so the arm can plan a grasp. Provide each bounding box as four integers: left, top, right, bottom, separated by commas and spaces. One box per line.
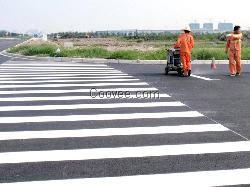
0, 40, 250, 187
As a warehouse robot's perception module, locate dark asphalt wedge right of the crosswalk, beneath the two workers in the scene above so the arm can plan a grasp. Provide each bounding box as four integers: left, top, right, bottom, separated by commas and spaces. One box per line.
113, 65, 250, 139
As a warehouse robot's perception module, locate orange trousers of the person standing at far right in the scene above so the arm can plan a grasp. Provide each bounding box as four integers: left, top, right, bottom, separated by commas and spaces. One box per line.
229, 50, 241, 74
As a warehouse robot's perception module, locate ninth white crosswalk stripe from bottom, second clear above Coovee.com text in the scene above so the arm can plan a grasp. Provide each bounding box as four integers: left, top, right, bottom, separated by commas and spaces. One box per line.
0, 79, 140, 84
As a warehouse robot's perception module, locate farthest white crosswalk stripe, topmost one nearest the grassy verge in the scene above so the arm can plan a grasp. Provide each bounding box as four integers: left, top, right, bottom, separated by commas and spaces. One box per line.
1, 62, 108, 67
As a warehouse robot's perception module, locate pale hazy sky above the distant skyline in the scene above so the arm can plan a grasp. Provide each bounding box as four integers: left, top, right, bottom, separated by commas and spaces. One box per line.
0, 0, 250, 33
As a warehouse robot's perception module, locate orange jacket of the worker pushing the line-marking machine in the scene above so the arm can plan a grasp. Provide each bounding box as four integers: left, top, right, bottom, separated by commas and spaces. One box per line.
174, 33, 194, 54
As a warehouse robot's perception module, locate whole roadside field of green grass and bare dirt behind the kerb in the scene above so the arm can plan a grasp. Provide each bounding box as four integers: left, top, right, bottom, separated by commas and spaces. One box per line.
9, 33, 250, 60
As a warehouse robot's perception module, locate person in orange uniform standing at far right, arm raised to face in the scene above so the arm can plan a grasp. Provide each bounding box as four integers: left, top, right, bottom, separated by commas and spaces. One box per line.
226, 26, 243, 77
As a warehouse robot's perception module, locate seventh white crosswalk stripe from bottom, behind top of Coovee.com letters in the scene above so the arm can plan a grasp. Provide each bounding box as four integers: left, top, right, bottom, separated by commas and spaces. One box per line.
0, 87, 158, 95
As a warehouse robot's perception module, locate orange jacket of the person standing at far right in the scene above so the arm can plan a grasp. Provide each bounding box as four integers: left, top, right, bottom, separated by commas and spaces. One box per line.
226, 33, 243, 51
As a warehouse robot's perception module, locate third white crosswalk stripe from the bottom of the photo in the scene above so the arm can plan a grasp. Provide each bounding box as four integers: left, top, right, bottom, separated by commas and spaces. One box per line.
0, 124, 229, 140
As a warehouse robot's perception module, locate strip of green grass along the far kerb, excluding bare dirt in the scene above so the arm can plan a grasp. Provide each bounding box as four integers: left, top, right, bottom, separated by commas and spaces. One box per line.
9, 42, 250, 60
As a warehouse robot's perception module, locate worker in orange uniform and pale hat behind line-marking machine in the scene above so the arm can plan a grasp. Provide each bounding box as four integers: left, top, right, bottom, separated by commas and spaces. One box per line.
174, 26, 194, 77
